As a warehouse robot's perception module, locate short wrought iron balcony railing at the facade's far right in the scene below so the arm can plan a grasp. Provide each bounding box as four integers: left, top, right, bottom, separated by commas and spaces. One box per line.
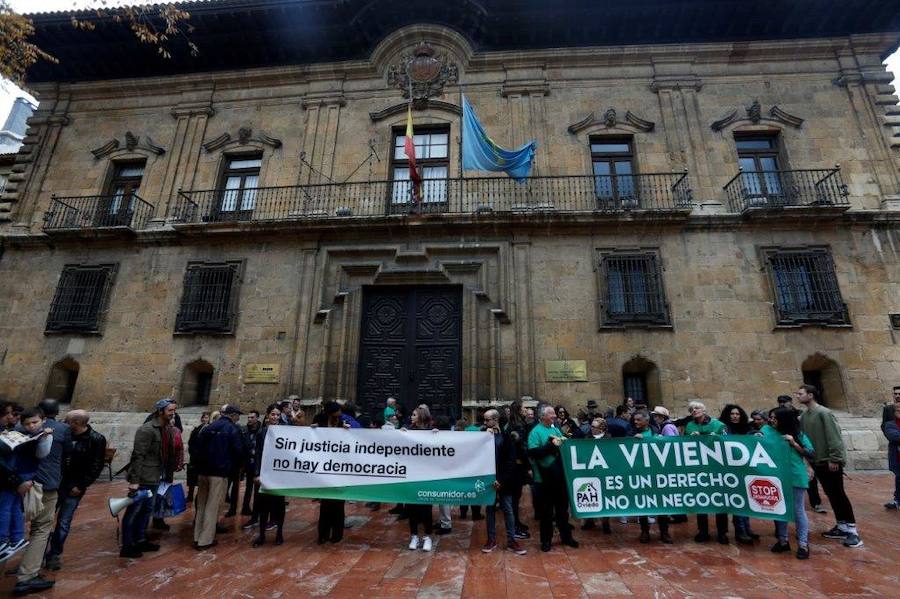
723, 166, 850, 212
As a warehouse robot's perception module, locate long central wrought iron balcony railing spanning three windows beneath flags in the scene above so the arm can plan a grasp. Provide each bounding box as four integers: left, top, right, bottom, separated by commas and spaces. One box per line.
171, 173, 691, 223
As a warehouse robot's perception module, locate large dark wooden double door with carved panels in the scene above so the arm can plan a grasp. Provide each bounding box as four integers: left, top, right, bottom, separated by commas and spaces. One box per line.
357, 285, 462, 422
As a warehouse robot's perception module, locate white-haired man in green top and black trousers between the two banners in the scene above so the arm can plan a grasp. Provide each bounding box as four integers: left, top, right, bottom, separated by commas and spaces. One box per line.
528, 406, 578, 551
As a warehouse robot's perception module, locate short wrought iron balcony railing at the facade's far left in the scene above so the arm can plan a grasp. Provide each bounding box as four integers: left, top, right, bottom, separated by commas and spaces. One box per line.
44, 194, 153, 231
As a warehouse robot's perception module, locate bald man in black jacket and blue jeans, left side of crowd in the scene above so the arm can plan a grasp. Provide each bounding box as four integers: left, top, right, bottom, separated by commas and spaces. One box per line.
45, 410, 106, 570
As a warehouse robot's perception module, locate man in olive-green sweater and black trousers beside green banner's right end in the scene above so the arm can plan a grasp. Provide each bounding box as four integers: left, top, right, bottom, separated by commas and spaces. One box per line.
796, 385, 863, 547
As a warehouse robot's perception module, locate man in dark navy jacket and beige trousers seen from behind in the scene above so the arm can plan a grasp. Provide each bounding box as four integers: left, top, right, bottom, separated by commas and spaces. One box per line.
194, 404, 247, 551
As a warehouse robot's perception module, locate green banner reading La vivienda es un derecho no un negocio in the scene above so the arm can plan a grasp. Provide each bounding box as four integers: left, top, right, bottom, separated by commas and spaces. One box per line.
560, 436, 794, 521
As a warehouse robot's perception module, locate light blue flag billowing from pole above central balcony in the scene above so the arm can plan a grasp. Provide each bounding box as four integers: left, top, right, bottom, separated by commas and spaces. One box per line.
464, 96, 537, 181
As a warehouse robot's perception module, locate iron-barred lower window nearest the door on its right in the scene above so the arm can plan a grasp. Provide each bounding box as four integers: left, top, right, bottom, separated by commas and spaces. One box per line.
595, 247, 673, 331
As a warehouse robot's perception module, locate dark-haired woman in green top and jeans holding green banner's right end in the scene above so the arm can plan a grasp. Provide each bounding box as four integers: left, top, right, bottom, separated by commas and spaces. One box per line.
772, 407, 815, 559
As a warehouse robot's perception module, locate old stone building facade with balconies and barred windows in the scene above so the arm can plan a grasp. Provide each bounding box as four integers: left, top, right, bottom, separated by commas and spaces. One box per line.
0, 2, 900, 422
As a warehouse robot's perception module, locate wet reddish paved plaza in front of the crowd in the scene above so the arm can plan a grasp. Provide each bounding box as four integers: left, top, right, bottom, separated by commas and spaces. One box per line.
0, 473, 900, 599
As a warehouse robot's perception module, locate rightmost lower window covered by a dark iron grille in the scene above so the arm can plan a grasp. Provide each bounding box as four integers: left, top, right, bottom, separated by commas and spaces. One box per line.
759, 245, 853, 329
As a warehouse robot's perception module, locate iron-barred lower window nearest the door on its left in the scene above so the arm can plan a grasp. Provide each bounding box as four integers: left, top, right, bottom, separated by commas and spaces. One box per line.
174, 260, 245, 336
